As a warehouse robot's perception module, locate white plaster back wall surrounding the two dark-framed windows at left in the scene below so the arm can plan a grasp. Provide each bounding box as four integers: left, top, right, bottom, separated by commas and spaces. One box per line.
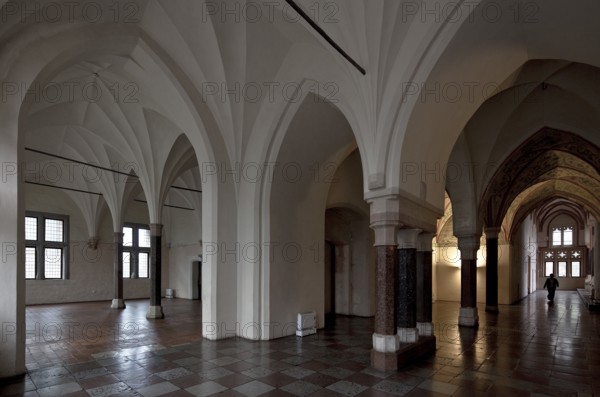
25, 185, 169, 305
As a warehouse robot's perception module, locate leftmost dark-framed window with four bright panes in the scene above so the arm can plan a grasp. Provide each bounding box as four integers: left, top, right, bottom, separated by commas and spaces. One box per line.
25, 211, 69, 280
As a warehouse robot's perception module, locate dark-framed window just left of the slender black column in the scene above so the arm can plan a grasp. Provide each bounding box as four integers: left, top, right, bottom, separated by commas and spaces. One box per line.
123, 223, 150, 278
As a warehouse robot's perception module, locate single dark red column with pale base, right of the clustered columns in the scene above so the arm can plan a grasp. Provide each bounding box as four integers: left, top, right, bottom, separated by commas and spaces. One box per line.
458, 236, 480, 327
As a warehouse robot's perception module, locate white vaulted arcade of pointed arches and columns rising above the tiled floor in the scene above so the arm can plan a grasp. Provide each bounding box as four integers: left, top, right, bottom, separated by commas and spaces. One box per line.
0, 0, 600, 378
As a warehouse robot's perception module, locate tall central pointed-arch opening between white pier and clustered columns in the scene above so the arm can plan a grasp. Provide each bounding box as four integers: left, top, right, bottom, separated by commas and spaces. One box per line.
269, 95, 373, 337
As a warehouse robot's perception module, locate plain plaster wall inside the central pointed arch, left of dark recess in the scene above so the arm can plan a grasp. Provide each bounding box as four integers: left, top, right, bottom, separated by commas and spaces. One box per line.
267, 96, 354, 337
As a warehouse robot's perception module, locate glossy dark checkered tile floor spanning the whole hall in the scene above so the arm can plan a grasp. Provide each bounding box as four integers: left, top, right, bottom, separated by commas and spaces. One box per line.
0, 291, 600, 397
